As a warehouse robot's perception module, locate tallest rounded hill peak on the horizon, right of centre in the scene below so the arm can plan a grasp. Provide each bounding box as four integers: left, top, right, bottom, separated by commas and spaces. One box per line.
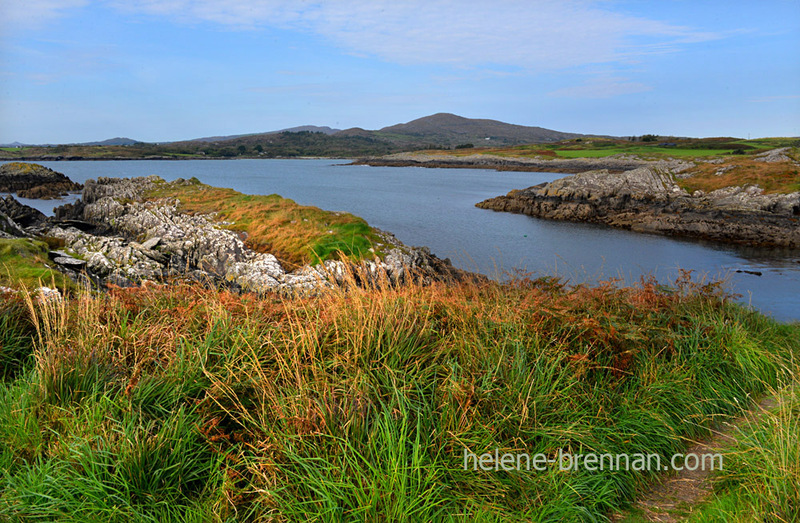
360, 113, 585, 146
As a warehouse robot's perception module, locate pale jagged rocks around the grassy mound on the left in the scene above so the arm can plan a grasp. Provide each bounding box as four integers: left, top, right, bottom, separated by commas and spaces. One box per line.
0, 172, 466, 293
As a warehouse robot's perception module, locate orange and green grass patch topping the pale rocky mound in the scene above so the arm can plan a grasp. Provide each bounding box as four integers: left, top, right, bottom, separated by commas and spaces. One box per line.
146, 178, 383, 267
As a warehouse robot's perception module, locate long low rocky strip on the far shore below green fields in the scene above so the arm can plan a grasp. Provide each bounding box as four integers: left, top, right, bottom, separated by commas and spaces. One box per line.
353, 153, 691, 173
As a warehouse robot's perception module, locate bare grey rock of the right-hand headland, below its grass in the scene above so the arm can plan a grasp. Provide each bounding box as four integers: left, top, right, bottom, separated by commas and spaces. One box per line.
477, 165, 800, 248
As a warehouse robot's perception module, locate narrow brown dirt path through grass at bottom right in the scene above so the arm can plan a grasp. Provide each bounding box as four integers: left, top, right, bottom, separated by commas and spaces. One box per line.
611, 396, 776, 523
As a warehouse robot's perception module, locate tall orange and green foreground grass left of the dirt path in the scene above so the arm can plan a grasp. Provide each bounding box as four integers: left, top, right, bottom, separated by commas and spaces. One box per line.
0, 272, 800, 521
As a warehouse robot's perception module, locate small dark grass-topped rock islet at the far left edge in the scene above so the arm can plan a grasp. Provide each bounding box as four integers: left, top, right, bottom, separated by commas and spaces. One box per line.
0, 162, 83, 200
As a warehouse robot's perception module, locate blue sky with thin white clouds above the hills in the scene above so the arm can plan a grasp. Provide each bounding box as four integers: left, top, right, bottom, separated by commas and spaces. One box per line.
0, 0, 800, 143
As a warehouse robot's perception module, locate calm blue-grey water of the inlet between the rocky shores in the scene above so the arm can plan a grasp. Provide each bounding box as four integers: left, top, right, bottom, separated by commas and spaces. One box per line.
6, 160, 800, 321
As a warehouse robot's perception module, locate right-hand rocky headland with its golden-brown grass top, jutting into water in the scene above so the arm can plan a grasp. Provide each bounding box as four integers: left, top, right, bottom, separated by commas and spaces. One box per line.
476, 147, 800, 249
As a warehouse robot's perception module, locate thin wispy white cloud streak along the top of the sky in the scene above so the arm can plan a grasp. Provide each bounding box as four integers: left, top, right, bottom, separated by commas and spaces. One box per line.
106, 0, 720, 70
